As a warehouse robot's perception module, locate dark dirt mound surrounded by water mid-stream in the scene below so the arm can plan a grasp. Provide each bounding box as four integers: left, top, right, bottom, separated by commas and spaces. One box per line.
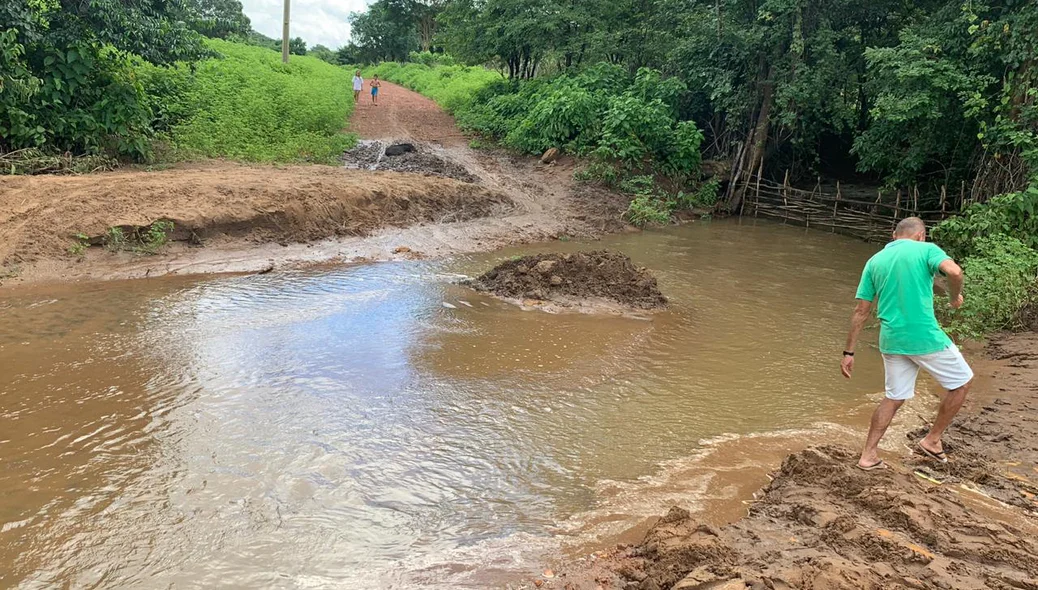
467, 250, 666, 310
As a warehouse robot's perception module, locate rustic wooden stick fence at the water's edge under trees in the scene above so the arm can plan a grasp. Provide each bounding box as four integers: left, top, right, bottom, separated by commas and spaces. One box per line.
739, 172, 958, 242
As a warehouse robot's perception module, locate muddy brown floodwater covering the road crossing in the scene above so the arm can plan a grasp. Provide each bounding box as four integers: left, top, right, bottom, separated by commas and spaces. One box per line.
0, 221, 896, 589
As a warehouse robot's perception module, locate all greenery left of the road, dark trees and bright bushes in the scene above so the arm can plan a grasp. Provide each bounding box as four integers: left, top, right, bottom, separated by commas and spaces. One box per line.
0, 0, 352, 168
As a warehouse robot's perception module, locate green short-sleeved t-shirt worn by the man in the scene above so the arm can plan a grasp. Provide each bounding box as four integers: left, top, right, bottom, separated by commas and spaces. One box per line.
855, 240, 952, 354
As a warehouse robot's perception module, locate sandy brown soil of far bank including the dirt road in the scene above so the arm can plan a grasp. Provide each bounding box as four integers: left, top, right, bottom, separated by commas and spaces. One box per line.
0, 83, 627, 286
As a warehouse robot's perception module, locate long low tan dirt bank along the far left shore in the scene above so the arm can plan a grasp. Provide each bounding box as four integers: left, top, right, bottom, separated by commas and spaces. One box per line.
0, 163, 512, 268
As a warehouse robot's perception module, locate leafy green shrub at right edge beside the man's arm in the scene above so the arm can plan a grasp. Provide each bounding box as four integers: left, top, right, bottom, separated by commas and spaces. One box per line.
947, 235, 1038, 339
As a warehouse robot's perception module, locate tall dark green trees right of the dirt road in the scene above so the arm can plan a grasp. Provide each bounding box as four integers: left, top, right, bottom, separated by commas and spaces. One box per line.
357, 0, 1038, 208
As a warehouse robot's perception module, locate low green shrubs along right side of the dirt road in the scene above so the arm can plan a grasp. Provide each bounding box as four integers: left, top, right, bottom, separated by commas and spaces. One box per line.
371, 58, 703, 180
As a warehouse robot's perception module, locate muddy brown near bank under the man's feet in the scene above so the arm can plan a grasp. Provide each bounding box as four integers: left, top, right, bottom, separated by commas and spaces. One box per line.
548, 332, 1038, 590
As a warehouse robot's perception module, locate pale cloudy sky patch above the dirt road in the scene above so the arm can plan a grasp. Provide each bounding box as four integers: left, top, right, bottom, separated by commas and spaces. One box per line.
241, 0, 368, 49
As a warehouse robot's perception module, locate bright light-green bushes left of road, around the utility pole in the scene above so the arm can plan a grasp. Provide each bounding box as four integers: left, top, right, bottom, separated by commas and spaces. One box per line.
161, 39, 356, 164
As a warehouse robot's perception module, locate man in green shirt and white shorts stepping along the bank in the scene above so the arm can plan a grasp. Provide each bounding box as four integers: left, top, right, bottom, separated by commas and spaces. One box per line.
841, 217, 974, 471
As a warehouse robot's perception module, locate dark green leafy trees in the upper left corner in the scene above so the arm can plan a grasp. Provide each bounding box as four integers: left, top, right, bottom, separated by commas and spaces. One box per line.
0, 0, 204, 158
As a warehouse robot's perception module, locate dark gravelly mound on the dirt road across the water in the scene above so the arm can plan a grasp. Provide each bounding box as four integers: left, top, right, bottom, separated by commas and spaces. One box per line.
343, 140, 476, 183
